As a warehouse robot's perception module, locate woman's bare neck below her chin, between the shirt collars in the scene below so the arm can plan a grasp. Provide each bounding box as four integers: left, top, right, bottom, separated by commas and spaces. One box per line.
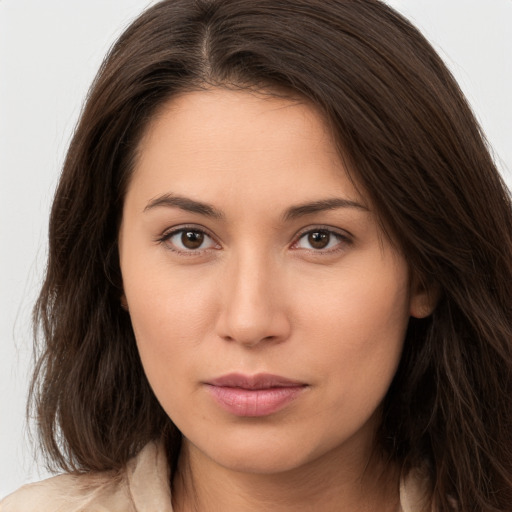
172, 442, 399, 512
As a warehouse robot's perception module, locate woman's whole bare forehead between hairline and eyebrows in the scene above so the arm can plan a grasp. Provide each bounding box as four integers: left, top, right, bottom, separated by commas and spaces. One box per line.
129, 88, 362, 213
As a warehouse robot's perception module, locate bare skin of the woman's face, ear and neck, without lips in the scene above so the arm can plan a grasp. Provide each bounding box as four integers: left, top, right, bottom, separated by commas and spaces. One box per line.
119, 88, 431, 511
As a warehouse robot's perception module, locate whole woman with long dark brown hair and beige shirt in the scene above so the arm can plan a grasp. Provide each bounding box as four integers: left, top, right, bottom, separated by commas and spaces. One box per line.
0, 0, 512, 512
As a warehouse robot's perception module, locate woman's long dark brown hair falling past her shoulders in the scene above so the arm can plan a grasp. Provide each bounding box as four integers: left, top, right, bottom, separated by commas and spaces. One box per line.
32, 0, 512, 512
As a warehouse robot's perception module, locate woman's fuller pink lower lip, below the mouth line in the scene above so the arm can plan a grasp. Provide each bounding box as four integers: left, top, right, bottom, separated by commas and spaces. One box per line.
208, 384, 306, 417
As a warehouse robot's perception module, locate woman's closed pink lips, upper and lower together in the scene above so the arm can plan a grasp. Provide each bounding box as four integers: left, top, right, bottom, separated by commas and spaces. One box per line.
206, 373, 307, 417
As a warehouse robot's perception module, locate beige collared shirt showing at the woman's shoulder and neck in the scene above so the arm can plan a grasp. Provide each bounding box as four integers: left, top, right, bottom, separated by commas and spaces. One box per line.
0, 443, 426, 512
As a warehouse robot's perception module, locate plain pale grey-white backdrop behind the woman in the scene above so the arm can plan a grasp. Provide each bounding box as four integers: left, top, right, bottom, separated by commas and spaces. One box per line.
0, 0, 512, 497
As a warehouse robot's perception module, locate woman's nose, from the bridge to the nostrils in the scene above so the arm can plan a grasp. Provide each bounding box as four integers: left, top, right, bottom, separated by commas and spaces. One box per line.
213, 252, 290, 347
